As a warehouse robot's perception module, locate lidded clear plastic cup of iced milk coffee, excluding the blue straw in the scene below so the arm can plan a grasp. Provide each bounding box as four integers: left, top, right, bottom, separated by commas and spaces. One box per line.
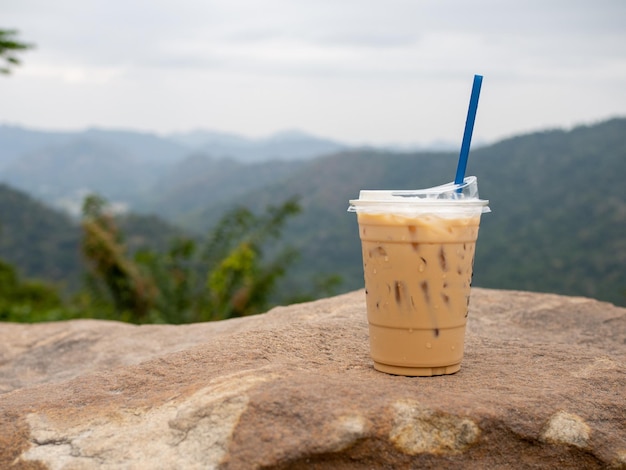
349, 177, 489, 376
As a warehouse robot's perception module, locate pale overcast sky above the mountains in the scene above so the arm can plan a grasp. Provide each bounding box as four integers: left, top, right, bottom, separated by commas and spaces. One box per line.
0, 0, 626, 145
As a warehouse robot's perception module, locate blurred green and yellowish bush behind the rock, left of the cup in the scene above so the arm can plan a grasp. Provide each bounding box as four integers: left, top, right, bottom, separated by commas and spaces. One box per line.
82, 196, 300, 323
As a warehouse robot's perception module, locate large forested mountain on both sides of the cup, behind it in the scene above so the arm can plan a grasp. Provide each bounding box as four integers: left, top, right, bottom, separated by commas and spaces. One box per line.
189, 119, 626, 305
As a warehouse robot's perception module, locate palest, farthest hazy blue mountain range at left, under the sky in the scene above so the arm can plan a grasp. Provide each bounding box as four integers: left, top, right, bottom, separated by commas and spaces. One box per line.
0, 125, 345, 215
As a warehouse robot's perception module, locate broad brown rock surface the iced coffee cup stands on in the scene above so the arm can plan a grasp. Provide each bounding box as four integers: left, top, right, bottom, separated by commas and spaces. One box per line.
0, 289, 626, 469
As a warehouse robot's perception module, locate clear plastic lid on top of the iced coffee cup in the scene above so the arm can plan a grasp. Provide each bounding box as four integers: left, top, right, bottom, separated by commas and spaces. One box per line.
348, 176, 490, 213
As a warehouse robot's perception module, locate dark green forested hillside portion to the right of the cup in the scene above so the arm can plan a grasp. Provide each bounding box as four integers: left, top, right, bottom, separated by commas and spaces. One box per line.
466, 119, 626, 305
